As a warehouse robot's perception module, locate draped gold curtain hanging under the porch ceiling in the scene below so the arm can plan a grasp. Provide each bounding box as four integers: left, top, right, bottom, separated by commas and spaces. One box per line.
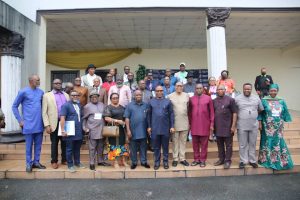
46, 48, 142, 69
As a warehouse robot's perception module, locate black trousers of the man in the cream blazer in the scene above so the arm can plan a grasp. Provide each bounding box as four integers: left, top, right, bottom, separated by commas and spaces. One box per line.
50, 123, 67, 163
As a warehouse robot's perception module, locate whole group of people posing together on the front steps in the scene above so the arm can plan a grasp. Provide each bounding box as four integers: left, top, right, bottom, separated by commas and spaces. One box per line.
12, 63, 293, 172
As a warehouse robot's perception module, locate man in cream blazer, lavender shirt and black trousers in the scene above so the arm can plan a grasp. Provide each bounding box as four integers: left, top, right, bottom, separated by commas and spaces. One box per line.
43, 79, 69, 169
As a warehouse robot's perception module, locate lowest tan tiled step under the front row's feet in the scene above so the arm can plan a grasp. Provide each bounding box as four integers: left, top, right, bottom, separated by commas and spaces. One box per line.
0, 155, 300, 179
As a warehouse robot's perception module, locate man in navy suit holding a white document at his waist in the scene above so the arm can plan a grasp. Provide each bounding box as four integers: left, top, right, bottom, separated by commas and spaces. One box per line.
58, 91, 85, 172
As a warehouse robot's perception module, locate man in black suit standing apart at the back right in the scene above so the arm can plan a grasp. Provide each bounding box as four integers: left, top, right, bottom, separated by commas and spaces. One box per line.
254, 67, 273, 98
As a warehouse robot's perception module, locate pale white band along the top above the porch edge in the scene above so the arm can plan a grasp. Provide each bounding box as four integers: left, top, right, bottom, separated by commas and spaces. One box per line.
3, 0, 300, 21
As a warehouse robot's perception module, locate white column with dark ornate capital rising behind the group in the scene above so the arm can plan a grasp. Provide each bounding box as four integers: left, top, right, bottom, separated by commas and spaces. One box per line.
206, 8, 230, 78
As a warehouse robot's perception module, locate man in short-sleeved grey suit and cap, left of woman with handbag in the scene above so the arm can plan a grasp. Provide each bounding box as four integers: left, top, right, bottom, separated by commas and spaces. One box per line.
82, 91, 110, 170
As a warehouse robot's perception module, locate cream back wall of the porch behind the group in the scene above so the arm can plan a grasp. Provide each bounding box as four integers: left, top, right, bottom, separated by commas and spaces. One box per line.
46, 49, 300, 110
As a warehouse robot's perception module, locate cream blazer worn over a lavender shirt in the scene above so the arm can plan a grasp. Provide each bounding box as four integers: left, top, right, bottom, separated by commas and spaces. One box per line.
42, 91, 70, 131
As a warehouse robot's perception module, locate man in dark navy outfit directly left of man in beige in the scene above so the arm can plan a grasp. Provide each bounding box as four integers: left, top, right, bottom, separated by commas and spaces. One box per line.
147, 86, 175, 170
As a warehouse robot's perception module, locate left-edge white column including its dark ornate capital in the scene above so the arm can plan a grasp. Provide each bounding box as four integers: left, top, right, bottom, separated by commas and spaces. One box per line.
0, 30, 24, 132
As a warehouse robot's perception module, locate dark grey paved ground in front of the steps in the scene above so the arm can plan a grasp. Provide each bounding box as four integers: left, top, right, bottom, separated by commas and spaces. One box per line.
0, 174, 300, 200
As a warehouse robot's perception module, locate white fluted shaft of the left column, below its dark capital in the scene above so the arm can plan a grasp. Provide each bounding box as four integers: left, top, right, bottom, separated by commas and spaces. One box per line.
1, 55, 23, 131
